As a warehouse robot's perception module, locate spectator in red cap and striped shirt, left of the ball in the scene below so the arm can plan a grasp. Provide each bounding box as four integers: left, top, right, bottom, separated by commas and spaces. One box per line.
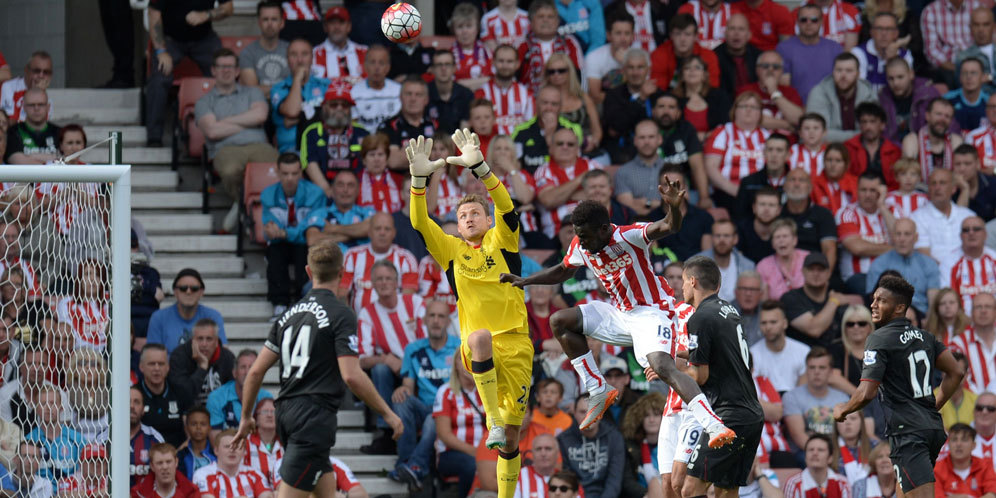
311, 7, 367, 83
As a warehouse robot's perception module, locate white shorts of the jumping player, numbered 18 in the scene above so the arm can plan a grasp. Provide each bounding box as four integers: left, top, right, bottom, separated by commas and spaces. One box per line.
578, 301, 674, 368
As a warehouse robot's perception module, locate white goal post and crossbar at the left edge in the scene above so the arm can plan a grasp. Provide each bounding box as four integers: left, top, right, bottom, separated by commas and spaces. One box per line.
0, 132, 132, 496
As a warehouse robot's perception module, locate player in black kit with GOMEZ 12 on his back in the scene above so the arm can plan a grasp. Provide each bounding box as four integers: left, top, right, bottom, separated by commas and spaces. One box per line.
833, 277, 965, 498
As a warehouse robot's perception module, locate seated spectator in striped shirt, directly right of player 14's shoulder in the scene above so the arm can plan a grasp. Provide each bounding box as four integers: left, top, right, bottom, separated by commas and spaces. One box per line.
357, 259, 425, 360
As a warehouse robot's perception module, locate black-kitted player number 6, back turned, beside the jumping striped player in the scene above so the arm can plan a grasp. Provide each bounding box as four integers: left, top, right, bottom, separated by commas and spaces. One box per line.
682, 256, 764, 498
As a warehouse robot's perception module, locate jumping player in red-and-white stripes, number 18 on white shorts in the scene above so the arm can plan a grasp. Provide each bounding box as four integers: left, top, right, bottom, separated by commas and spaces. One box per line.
503, 188, 735, 447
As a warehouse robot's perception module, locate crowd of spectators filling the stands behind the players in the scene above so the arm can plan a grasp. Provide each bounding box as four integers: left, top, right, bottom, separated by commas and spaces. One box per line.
0, 0, 996, 498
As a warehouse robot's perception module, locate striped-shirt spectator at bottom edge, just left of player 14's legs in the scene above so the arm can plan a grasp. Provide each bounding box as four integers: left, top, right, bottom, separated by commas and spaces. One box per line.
193, 429, 273, 498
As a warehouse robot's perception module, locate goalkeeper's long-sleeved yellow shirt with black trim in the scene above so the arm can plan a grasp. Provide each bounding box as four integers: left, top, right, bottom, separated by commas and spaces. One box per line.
410, 175, 529, 341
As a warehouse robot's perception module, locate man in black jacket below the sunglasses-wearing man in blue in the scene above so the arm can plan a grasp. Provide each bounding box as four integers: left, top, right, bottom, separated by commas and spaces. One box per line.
169, 318, 235, 405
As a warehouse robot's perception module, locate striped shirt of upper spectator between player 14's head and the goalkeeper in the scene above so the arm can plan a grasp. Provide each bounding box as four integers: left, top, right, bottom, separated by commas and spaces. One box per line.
339, 244, 418, 311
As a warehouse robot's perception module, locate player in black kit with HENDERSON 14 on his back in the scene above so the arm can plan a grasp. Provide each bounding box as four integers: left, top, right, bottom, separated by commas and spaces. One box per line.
231, 242, 404, 498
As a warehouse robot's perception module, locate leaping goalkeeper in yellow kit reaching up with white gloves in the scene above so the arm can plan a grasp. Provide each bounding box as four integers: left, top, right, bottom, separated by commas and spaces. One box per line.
405, 129, 533, 498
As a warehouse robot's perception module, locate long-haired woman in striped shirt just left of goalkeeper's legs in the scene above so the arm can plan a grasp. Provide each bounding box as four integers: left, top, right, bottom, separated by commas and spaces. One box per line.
432, 351, 488, 496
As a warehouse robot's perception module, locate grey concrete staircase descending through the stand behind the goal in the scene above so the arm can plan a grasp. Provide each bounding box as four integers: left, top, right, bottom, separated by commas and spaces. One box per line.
49, 89, 407, 496
